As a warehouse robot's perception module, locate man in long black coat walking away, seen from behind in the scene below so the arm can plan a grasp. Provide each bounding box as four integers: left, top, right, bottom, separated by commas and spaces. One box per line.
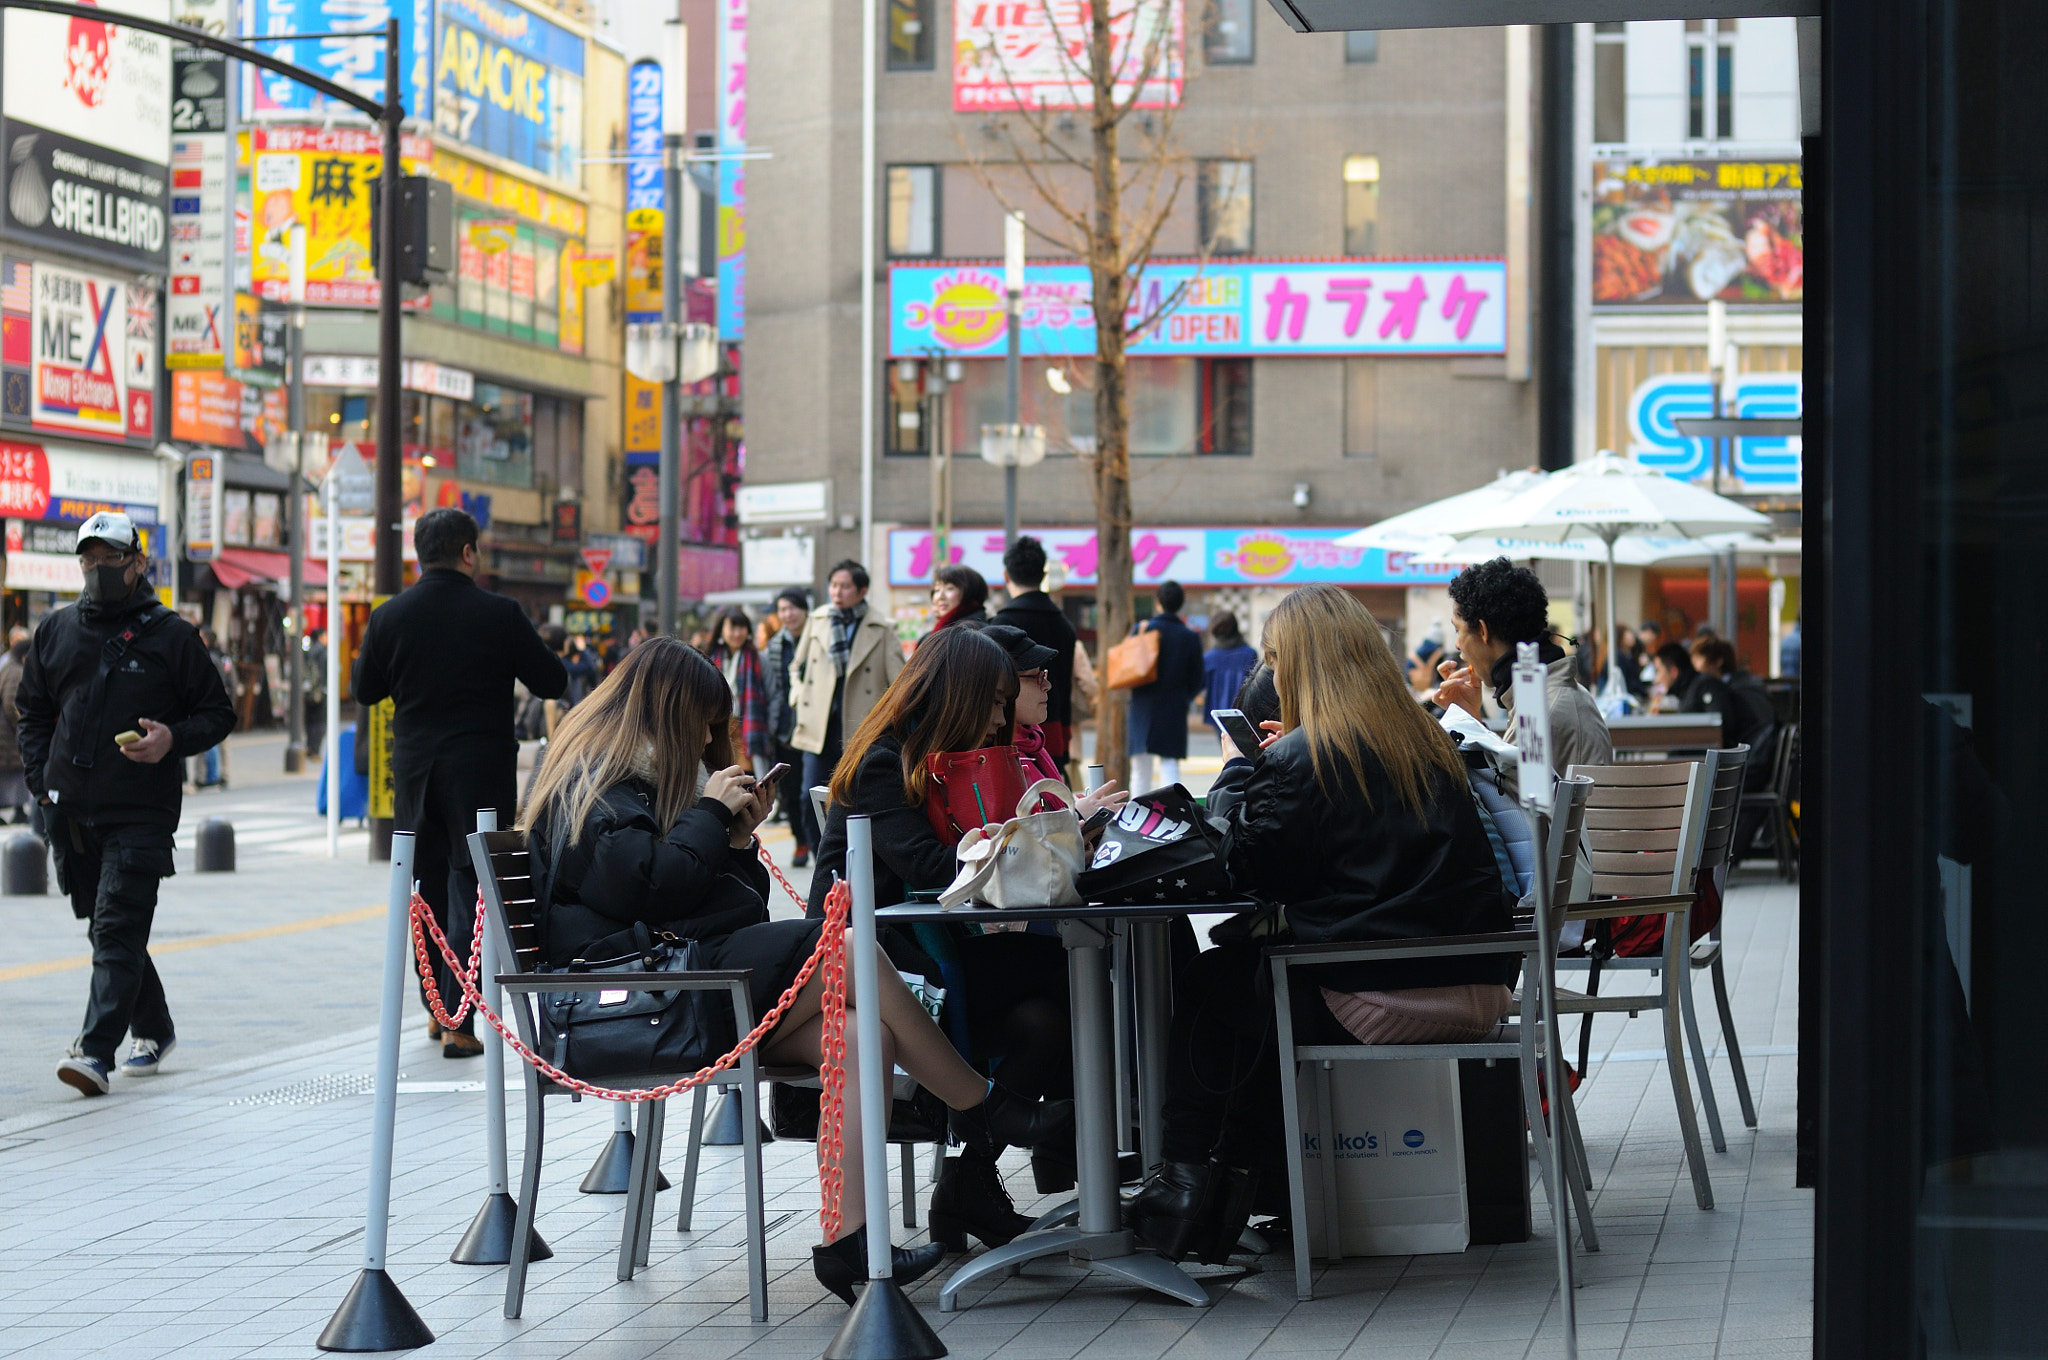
354, 508, 569, 1057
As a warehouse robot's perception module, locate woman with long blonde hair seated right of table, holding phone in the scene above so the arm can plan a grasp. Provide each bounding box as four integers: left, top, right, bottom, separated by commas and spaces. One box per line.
1130, 586, 1516, 1260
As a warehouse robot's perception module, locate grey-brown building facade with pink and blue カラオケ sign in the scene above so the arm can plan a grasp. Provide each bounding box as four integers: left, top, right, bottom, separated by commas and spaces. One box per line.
737, 0, 1536, 639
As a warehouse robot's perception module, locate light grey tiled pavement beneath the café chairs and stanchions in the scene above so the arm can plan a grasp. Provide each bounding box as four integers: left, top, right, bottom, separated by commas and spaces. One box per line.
0, 737, 1812, 1360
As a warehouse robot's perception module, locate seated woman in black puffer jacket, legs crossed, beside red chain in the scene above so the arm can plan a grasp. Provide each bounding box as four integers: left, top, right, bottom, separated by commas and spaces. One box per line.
520, 637, 1071, 1303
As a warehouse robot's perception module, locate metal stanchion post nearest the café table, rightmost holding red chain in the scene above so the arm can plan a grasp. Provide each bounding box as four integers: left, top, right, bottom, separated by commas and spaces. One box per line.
825, 817, 946, 1360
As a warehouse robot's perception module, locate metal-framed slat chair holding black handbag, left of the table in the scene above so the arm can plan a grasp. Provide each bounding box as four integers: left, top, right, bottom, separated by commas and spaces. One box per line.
469, 832, 778, 1323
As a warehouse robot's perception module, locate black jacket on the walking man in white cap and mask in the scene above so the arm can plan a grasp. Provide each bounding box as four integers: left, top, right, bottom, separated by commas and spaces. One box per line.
14, 588, 236, 832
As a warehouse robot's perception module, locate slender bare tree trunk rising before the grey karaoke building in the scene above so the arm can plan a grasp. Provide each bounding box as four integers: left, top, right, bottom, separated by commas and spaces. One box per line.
1087, 0, 1133, 787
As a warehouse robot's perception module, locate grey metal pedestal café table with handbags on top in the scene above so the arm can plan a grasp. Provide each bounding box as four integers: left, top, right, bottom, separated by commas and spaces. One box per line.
874, 901, 1253, 1313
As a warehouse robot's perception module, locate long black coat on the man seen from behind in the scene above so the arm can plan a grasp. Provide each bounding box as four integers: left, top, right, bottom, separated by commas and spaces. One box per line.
354, 567, 569, 832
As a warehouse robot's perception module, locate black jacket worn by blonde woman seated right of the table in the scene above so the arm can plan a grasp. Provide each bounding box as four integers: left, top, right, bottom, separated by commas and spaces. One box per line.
1208, 727, 1520, 991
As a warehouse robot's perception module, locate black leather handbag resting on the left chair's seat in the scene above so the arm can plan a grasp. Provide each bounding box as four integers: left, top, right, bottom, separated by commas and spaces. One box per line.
539, 924, 737, 1081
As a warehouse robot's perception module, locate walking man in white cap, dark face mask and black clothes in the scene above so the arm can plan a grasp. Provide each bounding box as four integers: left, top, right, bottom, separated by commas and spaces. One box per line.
14, 510, 236, 1096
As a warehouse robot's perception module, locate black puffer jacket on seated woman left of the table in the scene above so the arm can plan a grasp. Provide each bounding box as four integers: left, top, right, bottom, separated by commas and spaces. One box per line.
528, 780, 768, 967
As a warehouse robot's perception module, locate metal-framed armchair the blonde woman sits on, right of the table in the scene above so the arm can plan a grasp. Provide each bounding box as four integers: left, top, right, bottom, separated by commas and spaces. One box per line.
1268, 778, 1599, 1301
